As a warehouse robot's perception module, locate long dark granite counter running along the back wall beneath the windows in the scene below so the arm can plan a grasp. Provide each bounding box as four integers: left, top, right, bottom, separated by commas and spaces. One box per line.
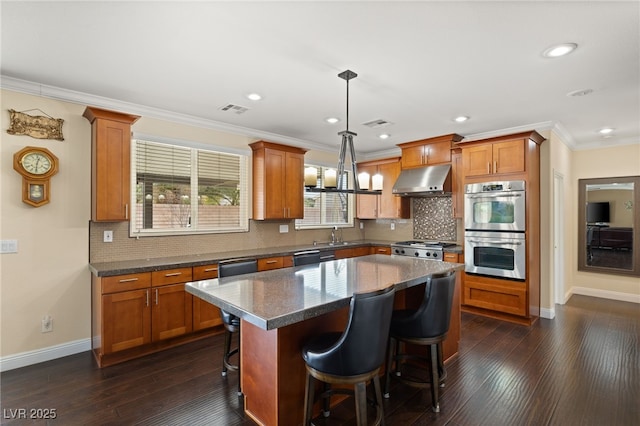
89, 240, 462, 277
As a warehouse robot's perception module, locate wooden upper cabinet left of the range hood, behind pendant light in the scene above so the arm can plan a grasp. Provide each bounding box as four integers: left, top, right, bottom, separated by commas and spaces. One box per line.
356, 157, 411, 219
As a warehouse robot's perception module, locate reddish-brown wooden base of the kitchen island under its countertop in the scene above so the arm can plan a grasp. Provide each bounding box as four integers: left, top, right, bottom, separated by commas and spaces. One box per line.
240, 307, 349, 426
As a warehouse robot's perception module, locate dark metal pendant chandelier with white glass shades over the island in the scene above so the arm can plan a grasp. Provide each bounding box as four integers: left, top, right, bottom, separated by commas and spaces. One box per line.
305, 70, 383, 195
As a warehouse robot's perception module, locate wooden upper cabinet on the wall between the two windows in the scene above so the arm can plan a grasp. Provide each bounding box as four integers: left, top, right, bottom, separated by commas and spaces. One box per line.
249, 141, 306, 220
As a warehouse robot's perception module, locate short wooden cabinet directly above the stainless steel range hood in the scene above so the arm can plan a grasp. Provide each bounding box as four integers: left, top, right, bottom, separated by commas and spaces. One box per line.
398, 133, 462, 169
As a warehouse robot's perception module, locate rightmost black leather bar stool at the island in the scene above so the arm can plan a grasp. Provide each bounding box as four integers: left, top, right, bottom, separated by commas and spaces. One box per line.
384, 271, 456, 413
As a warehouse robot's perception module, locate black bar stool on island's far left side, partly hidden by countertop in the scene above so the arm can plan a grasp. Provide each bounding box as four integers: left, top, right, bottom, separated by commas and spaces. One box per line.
218, 260, 258, 395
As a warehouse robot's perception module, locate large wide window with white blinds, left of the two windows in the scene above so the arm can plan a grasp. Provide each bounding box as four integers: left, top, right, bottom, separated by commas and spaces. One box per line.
131, 140, 248, 236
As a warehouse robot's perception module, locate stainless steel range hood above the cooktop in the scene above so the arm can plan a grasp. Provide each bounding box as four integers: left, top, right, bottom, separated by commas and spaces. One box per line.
392, 164, 451, 197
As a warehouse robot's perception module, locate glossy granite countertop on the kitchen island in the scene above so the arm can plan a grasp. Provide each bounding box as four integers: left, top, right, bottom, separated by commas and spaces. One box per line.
185, 254, 464, 330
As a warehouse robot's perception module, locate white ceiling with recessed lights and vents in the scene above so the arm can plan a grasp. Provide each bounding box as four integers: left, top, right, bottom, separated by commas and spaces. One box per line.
0, 0, 640, 157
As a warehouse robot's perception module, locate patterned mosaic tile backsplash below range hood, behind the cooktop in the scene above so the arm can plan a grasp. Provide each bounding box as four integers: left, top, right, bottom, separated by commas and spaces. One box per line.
413, 196, 457, 241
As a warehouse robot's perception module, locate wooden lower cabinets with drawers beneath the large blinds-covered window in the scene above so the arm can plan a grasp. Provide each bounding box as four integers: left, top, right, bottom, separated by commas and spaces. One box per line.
91, 267, 220, 367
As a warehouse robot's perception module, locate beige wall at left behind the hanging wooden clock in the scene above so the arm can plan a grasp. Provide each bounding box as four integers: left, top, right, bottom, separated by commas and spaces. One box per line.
0, 91, 91, 356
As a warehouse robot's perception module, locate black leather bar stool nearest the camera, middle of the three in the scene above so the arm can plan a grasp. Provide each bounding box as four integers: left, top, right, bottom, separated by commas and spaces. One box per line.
302, 287, 395, 425
